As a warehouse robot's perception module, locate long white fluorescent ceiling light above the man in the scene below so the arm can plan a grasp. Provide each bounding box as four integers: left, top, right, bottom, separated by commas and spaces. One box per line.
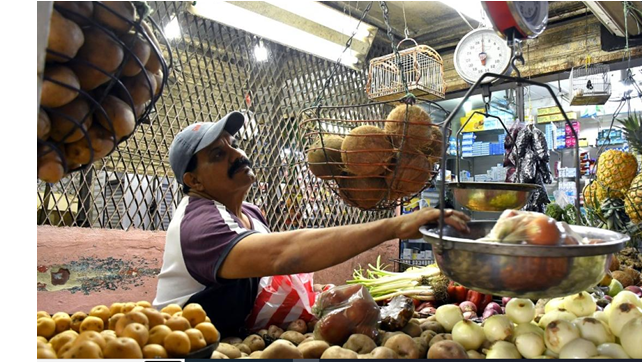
187, 1, 377, 69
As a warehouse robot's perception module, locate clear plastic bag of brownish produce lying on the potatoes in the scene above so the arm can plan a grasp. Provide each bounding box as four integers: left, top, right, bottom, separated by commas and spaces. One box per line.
313, 284, 380, 345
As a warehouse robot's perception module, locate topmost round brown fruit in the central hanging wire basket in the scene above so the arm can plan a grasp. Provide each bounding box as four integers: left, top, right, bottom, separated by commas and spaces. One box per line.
384, 104, 433, 152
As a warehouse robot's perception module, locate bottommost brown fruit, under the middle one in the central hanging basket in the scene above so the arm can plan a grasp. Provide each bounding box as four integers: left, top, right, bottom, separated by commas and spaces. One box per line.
338, 175, 388, 209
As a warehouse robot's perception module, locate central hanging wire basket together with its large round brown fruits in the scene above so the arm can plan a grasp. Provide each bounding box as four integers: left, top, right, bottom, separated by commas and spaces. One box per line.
298, 99, 448, 210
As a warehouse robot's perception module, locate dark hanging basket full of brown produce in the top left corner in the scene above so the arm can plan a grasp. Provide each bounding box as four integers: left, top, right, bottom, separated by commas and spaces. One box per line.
38, 1, 171, 183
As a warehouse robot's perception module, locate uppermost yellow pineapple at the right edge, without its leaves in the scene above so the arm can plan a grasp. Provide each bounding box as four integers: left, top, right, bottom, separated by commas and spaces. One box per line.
597, 150, 638, 199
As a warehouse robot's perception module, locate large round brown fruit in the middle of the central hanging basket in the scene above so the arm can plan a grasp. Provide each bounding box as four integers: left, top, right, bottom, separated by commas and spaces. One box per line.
341, 126, 394, 176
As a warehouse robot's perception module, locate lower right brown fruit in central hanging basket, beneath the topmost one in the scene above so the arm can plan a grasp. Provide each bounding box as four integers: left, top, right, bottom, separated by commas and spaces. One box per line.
386, 154, 432, 200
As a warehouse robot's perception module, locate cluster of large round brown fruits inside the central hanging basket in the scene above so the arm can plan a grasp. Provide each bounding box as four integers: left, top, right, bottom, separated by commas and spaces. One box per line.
307, 104, 442, 210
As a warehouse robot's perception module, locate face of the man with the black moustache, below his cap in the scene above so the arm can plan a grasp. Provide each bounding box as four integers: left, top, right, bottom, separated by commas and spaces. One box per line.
188, 131, 256, 199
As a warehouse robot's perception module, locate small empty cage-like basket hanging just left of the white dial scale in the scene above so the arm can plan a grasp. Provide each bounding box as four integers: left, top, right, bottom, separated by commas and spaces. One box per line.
366, 38, 446, 101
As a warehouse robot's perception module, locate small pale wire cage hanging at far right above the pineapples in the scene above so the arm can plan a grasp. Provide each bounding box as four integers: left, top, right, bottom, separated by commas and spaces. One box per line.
569, 63, 611, 106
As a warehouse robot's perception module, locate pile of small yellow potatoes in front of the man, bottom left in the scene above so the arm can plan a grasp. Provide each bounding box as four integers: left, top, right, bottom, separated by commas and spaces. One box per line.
38, 301, 220, 358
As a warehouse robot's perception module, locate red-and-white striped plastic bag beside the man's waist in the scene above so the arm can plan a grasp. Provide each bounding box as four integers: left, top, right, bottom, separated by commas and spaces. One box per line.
246, 273, 317, 331
